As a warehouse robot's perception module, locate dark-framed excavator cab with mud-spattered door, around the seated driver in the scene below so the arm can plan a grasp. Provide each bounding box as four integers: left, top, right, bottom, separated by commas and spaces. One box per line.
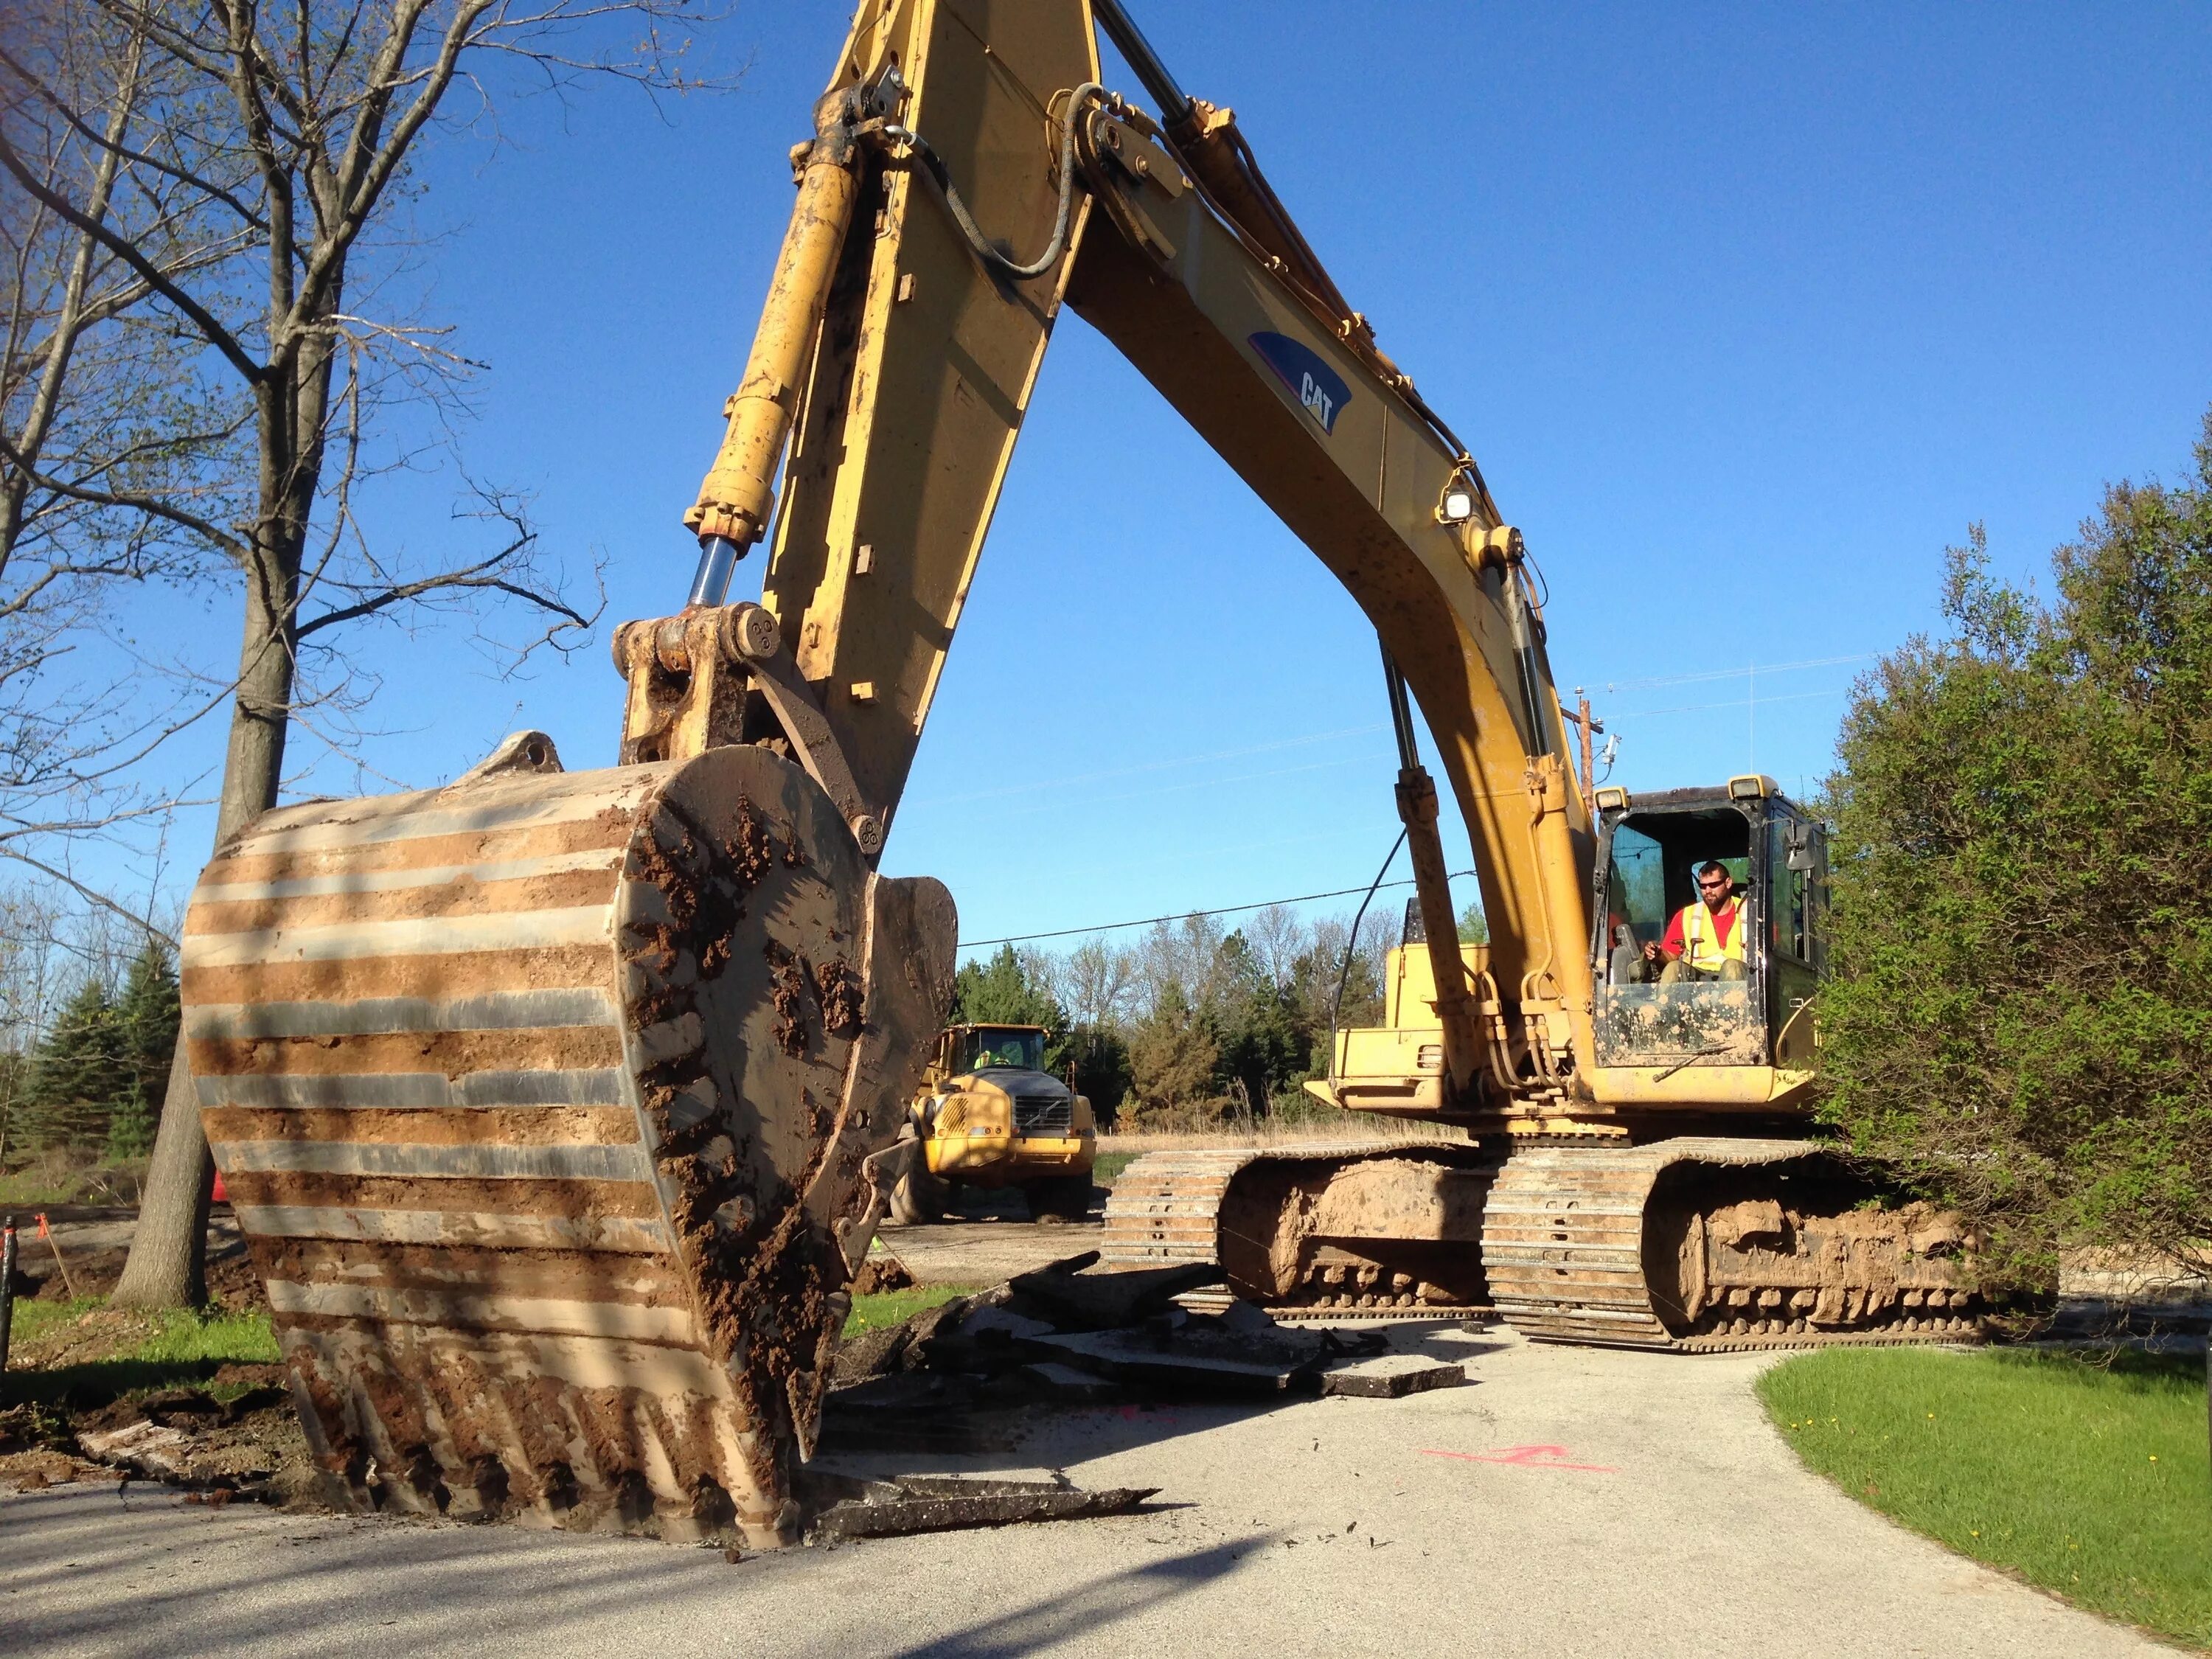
1593, 776, 1827, 1093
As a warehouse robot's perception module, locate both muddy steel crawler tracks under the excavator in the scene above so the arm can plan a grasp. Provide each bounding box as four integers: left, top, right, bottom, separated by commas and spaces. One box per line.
1104, 1137, 1991, 1354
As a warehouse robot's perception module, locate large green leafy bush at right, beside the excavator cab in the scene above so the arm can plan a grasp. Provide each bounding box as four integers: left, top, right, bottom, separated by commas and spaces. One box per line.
1823, 416, 2212, 1279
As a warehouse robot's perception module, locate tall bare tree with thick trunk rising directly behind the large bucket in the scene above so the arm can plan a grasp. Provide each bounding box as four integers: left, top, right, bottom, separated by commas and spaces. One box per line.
0, 0, 717, 1307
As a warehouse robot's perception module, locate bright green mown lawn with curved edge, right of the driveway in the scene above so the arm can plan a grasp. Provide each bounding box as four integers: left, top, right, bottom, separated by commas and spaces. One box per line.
1759, 1349, 2212, 1648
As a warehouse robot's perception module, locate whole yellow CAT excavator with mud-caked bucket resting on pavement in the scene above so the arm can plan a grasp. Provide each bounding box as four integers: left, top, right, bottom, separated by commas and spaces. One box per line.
184, 0, 1982, 1544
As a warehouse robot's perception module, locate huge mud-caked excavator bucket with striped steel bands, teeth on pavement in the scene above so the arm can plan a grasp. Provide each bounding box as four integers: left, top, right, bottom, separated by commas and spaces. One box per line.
184, 734, 956, 1544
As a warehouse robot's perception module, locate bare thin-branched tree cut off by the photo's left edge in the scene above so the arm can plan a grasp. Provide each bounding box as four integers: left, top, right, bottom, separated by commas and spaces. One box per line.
0, 0, 250, 938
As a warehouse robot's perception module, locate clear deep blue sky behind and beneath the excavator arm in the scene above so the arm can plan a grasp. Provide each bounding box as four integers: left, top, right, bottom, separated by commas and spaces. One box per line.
100, 0, 2212, 956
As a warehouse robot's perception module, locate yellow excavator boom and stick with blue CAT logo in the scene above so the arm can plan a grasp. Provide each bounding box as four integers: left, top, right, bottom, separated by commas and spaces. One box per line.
681, 0, 1590, 1117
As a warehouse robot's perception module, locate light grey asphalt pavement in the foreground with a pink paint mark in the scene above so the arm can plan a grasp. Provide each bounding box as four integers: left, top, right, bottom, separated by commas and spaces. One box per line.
0, 1327, 2168, 1659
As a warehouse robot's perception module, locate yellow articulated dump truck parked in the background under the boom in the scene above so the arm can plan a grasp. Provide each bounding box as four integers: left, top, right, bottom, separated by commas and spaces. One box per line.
891, 1024, 1099, 1223
